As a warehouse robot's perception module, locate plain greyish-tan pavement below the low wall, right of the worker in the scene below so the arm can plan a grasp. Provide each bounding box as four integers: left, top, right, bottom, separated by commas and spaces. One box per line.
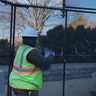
6, 78, 96, 96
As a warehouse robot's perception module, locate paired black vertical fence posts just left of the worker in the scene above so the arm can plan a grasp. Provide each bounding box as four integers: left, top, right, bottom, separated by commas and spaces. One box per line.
7, 5, 16, 96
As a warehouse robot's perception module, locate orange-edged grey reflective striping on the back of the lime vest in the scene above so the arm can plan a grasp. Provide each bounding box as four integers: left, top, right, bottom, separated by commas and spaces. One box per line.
13, 46, 41, 74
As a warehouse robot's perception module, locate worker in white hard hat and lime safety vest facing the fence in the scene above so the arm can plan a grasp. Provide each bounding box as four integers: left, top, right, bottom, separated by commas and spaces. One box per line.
9, 27, 55, 96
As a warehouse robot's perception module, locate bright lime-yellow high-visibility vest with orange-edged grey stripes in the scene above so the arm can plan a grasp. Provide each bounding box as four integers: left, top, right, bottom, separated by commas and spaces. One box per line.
9, 45, 42, 90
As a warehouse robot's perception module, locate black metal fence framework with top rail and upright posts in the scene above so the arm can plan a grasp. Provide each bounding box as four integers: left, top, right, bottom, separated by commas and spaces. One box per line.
0, 0, 96, 96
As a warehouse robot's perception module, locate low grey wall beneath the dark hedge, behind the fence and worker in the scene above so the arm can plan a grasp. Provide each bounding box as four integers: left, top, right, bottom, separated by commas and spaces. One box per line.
0, 63, 96, 81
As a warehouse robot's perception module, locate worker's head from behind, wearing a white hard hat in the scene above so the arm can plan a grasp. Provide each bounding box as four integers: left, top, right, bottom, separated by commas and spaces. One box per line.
21, 27, 38, 47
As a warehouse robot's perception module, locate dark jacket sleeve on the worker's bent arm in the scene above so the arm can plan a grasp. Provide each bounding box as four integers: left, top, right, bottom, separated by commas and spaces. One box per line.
27, 49, 54, 71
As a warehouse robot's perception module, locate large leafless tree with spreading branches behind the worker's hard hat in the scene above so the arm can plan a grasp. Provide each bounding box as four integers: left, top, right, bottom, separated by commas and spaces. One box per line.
0, 0, 76, 36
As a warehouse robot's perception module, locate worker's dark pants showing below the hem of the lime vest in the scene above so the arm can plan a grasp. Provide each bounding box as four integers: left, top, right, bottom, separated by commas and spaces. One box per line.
13, 89, 39, 96
